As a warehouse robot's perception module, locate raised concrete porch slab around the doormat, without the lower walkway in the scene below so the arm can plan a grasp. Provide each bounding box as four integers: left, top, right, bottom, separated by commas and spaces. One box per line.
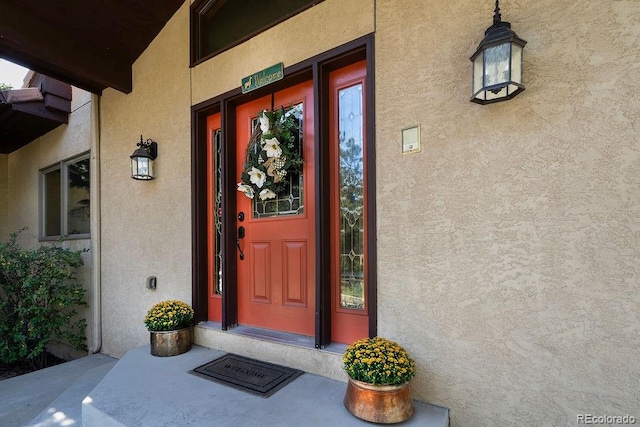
82, 346, 449, 427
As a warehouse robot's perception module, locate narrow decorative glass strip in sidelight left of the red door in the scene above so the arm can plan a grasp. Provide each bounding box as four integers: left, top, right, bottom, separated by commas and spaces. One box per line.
213, 129, 222, 295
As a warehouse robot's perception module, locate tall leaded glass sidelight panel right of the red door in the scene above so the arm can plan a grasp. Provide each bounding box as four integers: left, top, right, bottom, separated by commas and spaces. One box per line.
338, 84, 365, 310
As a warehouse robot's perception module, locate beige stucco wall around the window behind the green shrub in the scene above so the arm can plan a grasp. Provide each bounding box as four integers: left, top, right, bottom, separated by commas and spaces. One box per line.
0, 88, 94, 358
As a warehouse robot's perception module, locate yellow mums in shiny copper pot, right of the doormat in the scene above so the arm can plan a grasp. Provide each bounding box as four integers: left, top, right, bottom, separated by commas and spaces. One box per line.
342, 337, 416, 424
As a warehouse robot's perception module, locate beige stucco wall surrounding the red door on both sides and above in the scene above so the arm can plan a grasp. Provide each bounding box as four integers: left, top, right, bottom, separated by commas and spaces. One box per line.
101, 0, 640, 426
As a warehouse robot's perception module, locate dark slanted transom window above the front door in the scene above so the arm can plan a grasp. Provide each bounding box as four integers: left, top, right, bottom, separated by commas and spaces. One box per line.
191, 0, 323, 65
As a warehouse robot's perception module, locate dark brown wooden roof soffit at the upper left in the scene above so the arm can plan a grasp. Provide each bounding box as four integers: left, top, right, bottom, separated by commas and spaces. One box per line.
0, 0, 184, 94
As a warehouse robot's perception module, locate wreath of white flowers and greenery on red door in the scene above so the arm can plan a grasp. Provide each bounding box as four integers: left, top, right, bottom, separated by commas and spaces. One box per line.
238, 104, 303, 201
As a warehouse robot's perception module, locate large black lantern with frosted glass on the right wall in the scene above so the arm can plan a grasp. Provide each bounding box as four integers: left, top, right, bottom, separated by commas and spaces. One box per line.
471, 0, 527, 104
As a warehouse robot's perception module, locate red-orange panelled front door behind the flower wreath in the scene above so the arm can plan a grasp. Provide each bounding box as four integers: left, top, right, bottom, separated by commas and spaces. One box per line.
236, 81, 316, 336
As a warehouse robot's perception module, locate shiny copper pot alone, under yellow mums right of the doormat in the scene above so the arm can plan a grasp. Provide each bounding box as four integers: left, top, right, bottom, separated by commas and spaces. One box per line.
344, 378, 414, 424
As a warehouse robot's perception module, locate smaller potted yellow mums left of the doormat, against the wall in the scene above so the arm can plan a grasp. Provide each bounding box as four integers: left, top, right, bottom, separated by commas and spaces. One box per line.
144, 300, 193, 357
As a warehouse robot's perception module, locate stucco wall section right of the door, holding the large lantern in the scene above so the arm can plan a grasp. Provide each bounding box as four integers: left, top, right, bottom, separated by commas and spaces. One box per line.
376, 0, 640, 426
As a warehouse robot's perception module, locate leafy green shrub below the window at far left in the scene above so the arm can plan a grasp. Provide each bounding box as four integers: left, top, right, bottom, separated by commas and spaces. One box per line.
0, 232, 87, 368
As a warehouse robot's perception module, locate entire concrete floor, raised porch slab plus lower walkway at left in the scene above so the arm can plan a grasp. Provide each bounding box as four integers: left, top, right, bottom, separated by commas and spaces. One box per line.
0, 345, 449, 427
